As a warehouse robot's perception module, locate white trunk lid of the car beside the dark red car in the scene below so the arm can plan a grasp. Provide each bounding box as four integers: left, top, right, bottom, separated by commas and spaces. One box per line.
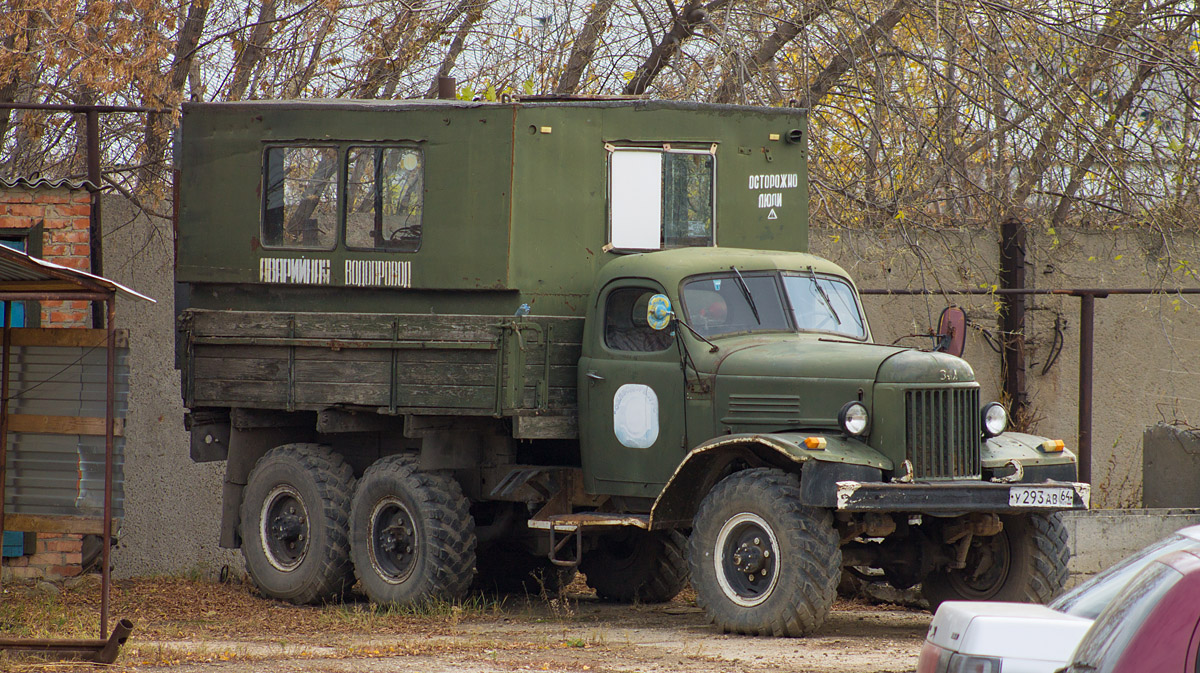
926, 601, 1092, 673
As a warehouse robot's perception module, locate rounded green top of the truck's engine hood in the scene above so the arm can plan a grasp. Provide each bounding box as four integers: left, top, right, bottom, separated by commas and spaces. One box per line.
718, 335, 974, 383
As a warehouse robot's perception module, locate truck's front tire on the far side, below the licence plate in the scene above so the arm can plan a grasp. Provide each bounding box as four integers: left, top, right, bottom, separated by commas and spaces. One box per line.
922, 512, 1070, 611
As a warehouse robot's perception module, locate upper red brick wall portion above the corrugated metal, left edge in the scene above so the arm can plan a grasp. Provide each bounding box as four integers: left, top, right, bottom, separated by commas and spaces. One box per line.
0, 187, 91, 328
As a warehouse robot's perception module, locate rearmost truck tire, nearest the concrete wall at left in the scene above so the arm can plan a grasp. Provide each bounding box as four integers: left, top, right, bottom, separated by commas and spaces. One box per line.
241, 444, 354, 605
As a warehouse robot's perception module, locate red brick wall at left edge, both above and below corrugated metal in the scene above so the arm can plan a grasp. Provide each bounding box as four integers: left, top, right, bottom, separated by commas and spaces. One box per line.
0, 186, 91, 579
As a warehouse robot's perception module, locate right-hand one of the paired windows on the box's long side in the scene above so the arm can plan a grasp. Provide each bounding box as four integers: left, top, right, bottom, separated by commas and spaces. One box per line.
346, 148, 425, 252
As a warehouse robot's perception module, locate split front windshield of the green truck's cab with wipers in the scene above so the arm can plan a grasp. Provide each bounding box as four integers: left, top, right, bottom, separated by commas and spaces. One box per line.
683, 269, 866, 338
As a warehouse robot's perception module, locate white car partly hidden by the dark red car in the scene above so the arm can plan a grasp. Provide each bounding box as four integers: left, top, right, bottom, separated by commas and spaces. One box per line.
917, 525, 1200, 673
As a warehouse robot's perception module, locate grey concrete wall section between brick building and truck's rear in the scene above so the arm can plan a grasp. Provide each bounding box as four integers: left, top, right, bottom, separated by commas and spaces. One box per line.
102, 198, 241, 577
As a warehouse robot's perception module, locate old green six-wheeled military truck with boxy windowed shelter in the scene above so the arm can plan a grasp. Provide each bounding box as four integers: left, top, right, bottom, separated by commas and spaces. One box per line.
176, 100, 1088, 636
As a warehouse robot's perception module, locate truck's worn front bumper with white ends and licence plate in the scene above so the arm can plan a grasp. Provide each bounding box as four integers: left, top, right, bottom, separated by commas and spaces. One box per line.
836, 481, 1092, 516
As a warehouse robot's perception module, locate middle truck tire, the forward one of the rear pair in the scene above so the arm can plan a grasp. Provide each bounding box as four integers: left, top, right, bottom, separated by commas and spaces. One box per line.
350, 455, 476, 606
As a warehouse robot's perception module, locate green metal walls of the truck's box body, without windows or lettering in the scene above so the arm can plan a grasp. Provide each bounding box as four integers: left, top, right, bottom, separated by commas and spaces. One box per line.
176, 101, 808, 316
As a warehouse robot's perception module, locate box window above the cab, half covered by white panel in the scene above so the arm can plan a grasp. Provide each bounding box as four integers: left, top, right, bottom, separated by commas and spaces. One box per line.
607, 145, 716, 250
